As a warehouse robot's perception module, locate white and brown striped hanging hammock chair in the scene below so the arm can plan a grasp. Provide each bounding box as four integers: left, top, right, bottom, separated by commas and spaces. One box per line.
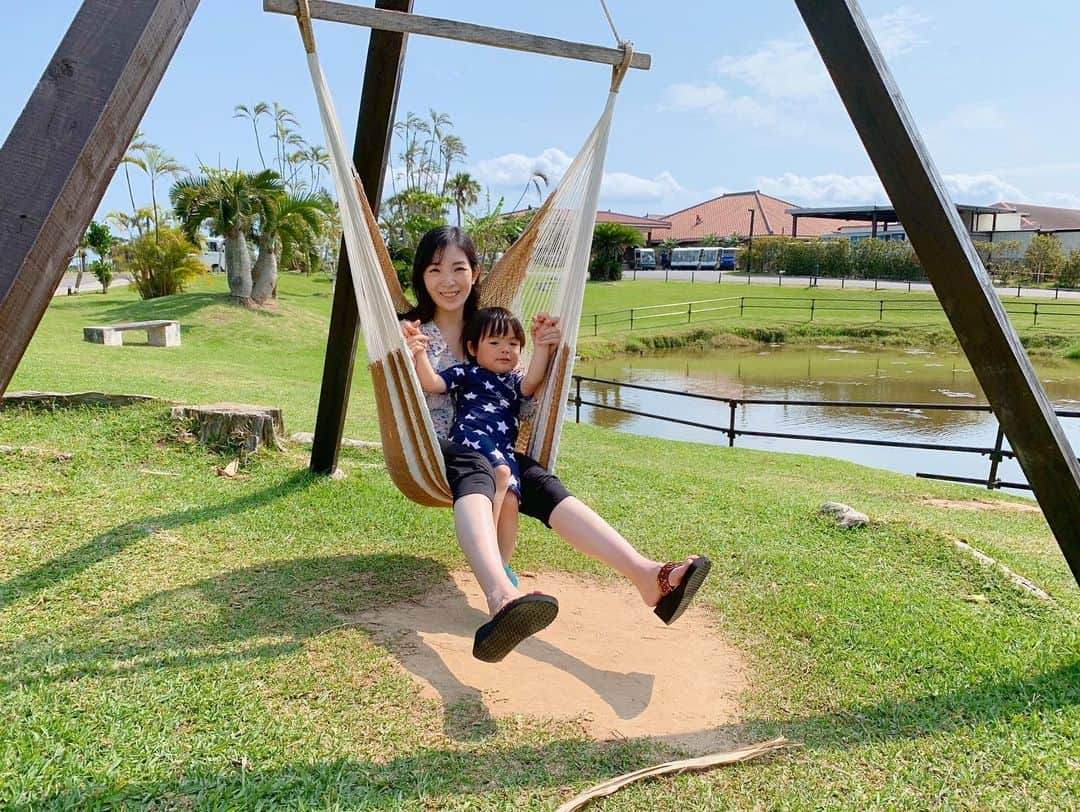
298, 2, 633, 506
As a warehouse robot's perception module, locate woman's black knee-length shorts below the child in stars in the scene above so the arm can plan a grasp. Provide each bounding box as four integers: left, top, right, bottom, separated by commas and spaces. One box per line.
438, 437, 570, 527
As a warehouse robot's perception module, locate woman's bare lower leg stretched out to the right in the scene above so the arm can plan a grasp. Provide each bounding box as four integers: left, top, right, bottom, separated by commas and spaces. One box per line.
549, 497, 691, 606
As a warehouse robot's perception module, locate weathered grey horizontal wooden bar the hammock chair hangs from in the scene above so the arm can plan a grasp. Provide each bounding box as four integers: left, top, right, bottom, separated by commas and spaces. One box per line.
262, 0, 652, 70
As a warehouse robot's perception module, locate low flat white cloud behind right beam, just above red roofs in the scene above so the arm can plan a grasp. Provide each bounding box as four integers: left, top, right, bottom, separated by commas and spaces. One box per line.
758, 172, 1027, 205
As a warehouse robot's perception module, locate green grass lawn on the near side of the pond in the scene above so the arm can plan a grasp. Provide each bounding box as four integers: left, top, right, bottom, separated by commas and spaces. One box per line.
0, 278, 1080, 810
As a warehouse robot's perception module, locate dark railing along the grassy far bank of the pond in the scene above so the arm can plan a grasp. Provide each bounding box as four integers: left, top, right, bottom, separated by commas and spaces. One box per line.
580, 296, 1080, 336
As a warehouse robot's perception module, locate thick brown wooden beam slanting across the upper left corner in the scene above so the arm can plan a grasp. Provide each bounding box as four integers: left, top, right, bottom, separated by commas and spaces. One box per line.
0, 0, 199, 394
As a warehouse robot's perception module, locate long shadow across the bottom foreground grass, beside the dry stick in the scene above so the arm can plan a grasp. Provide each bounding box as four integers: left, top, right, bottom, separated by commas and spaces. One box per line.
25, 663, 1080, 809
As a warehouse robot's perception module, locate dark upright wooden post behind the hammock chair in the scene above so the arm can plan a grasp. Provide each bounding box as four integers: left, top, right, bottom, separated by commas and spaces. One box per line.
311, 0, 413, 474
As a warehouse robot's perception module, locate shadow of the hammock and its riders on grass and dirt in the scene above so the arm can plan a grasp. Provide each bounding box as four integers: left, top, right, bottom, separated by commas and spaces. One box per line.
0, 554, 652, 740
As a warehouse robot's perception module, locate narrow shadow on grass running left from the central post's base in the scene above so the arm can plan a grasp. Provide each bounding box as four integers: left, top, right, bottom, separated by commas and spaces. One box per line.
0, 470, 320, 611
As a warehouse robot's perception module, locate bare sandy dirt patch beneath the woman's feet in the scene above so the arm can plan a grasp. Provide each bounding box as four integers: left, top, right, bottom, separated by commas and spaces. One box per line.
349, 572, 748, 753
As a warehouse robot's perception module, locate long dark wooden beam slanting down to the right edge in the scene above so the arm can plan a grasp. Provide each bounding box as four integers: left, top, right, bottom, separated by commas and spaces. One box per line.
795, 0, 1080, 583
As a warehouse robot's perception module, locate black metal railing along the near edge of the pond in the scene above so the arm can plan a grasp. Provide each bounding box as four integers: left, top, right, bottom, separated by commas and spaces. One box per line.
570, 375, 1080, 490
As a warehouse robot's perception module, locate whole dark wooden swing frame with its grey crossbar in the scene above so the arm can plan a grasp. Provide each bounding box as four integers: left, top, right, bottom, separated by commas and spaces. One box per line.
0, 0, 1080, 583
